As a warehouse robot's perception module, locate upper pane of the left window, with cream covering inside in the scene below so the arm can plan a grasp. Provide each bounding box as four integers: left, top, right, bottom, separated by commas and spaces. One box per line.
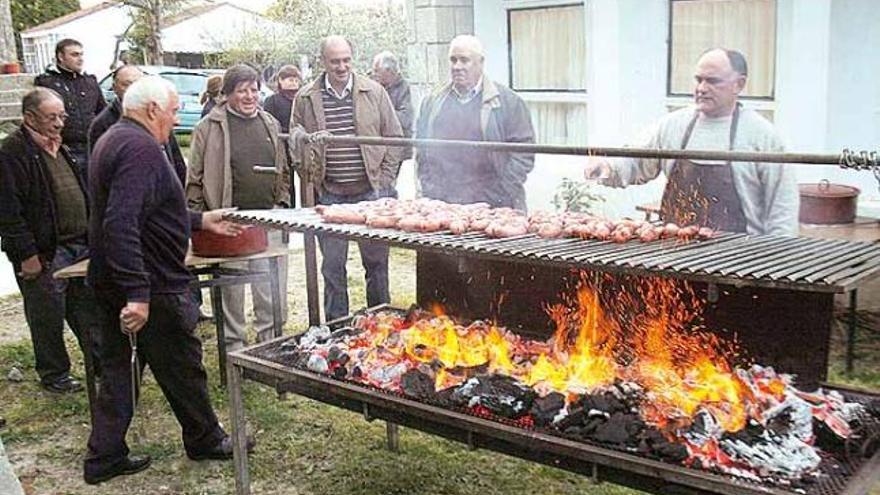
507, 5, 587, 92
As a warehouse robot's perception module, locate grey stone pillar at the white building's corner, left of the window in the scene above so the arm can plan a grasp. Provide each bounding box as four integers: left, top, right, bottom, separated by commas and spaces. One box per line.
406, 0, 474, 102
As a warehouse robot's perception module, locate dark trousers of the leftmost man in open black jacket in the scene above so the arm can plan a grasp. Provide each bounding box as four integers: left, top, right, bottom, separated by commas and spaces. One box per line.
15, 238, 96, 384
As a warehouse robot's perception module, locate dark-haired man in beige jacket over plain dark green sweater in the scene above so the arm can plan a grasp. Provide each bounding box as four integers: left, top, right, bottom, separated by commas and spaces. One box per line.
186, 65, 291, 350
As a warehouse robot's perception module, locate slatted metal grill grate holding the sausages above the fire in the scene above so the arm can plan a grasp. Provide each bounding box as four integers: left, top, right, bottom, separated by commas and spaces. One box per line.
229, 208, 880, 292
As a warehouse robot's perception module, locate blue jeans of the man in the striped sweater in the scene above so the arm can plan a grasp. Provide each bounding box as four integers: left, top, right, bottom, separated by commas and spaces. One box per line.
318, 191, 391, 320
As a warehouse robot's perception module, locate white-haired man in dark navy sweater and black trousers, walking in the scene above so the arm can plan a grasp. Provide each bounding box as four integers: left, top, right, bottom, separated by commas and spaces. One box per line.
84, 76, 248, 484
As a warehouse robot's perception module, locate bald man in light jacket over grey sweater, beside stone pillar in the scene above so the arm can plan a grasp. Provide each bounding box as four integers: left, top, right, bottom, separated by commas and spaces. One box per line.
416, 35, 535, 210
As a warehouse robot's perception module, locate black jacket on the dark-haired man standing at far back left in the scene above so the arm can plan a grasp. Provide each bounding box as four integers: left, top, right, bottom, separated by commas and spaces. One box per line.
34, 66, 107, 151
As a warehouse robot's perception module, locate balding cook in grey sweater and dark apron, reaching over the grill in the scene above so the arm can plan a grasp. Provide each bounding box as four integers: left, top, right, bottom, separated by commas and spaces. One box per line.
584, 48, 798, 235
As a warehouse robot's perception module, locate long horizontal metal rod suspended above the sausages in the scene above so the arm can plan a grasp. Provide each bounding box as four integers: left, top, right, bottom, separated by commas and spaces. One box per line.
281, 134, 880, 170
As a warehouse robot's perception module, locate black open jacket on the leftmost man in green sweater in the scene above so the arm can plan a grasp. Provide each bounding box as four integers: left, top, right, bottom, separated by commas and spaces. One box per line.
0, 126, 88, 271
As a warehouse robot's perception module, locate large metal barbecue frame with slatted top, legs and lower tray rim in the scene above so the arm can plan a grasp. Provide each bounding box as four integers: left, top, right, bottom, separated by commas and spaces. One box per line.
227, 208, 880, 495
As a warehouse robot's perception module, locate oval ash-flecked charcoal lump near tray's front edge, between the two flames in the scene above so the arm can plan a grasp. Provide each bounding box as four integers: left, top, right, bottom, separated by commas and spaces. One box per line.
453, 374, 536, 419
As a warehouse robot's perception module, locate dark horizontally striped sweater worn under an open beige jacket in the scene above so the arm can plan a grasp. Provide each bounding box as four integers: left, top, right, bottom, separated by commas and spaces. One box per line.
321, 85, 370, 194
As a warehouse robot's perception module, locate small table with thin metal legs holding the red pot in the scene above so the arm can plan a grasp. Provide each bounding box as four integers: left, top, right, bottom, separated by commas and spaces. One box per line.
53, 247, 287, 414
